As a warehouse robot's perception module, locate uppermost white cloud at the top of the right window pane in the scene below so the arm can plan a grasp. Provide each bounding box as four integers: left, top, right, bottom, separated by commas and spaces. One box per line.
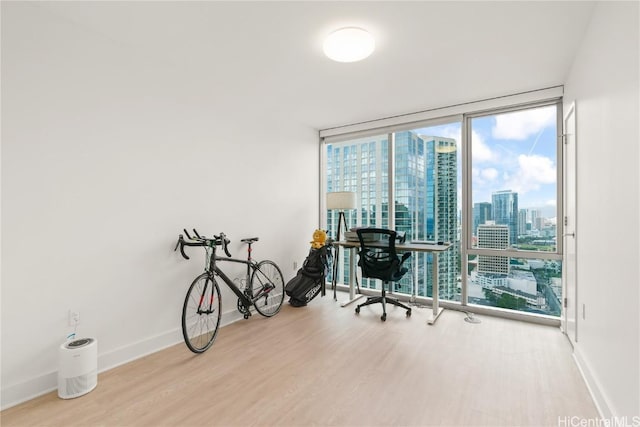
491, 106, 556, 140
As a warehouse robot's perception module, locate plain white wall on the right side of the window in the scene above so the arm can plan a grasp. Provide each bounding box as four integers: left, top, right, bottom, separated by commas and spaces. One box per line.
565, 2, 640, 422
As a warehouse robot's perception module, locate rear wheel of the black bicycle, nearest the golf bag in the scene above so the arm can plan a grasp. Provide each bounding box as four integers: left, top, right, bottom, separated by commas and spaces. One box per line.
251, 261, 284, 317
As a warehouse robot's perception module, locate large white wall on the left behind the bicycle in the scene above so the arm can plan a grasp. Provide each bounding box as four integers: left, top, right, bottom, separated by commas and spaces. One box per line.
2, 2, 319, 408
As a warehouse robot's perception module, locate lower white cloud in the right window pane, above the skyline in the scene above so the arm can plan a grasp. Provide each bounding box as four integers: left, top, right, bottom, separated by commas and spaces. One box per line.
506, 154, 556, 194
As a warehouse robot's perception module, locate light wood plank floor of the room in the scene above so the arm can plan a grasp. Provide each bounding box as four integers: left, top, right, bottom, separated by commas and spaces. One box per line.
0, 295, 598, 427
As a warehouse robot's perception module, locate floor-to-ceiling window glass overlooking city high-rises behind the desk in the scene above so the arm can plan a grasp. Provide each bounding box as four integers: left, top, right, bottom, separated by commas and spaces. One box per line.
322, 93, 562, 316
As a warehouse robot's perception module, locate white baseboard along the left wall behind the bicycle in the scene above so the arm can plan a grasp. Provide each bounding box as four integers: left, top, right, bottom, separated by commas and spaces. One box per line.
0, 309, 243, 410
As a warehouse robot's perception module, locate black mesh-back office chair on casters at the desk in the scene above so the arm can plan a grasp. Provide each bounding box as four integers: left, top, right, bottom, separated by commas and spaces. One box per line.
356, 228, 411, 322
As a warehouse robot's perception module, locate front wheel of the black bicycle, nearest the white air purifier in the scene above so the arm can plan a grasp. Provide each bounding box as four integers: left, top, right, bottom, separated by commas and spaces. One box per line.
182, 273, 222, 353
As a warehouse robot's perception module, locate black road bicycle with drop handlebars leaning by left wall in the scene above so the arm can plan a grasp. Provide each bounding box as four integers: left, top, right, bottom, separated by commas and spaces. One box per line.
174, 229, 284, 353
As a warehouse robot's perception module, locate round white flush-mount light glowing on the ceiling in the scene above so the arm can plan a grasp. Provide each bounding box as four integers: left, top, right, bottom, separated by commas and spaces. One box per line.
322, 27, 376, 62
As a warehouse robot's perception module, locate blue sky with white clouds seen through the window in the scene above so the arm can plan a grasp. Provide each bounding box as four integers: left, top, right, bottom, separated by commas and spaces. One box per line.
416, 106, 557, 218
